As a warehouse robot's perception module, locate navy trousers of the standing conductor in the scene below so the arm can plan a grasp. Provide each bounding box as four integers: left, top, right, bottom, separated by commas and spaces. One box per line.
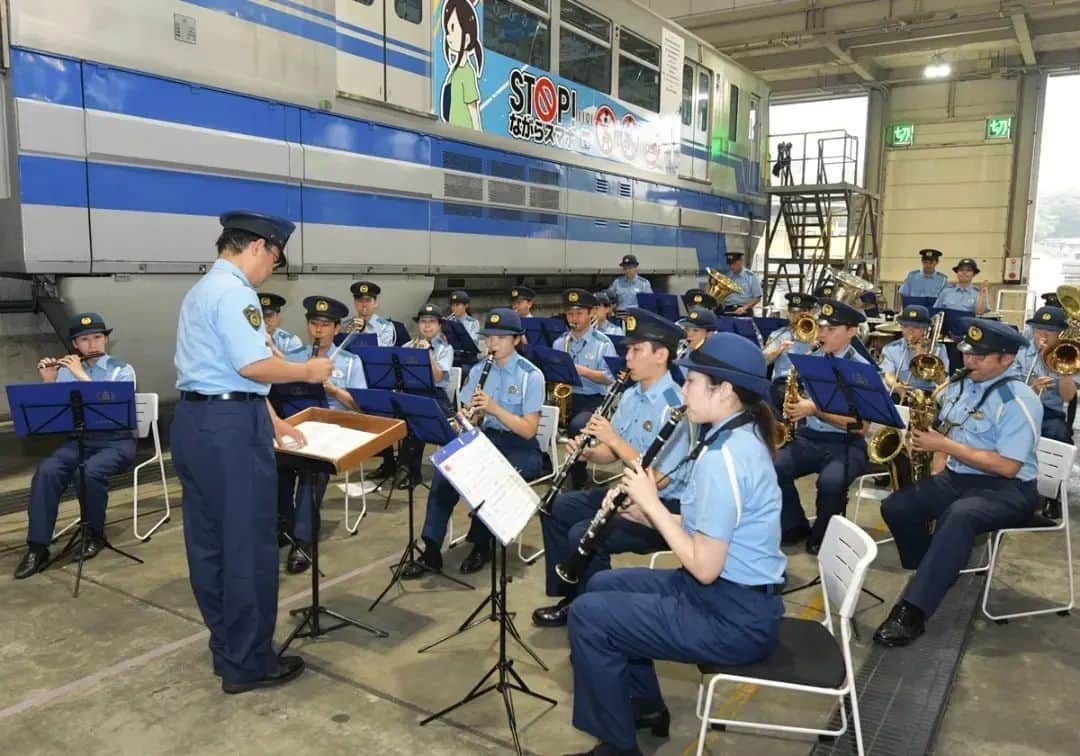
172, 401, 278, 683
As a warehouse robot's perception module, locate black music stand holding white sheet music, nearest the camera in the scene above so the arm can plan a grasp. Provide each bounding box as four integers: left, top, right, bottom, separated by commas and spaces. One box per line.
419, 423, 558, 755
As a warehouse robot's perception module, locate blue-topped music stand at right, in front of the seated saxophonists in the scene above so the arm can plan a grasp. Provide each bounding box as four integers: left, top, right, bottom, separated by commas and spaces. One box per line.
784, 354, 904, 604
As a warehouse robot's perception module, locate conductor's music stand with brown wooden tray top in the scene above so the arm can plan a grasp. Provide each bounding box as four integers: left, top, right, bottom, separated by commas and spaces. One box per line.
276, 407, 405, 657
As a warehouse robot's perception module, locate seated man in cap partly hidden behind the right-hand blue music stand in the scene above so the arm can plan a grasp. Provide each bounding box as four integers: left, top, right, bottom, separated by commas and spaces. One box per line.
777, 299, 869, 554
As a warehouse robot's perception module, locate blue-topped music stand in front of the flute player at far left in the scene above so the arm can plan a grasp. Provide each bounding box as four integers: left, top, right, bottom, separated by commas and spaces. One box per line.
8, 381, 144, 598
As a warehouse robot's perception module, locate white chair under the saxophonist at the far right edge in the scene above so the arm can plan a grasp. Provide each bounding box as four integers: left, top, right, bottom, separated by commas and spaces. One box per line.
983, 438, 1077, 624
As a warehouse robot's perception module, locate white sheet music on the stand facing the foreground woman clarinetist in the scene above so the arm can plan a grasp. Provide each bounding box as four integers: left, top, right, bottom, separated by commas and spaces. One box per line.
431, 430, 540, 545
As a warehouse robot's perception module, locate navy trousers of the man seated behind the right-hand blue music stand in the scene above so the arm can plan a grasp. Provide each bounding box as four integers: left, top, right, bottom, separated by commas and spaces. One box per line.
775, 429, 866, 543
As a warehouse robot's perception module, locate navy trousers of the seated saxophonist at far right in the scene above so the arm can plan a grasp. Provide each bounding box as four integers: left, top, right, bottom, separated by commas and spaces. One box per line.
881, 470, 1038, 617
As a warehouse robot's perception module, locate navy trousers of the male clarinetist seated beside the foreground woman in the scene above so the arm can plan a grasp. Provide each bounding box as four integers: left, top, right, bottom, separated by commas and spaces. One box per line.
540, 488, 679, 598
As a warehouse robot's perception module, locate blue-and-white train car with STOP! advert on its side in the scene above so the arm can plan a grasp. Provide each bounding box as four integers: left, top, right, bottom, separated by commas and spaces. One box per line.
0, 0, 769, 396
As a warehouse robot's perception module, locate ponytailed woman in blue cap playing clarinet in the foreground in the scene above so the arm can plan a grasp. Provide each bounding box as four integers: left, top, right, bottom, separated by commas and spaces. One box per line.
569, 334, 786, 754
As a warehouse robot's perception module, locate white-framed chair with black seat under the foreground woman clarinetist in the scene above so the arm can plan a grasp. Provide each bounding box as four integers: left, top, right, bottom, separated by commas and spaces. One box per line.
698, 515, 877, 756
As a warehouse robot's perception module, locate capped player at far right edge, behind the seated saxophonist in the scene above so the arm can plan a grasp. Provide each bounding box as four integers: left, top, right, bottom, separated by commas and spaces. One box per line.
1015, 307, 1078, 444
